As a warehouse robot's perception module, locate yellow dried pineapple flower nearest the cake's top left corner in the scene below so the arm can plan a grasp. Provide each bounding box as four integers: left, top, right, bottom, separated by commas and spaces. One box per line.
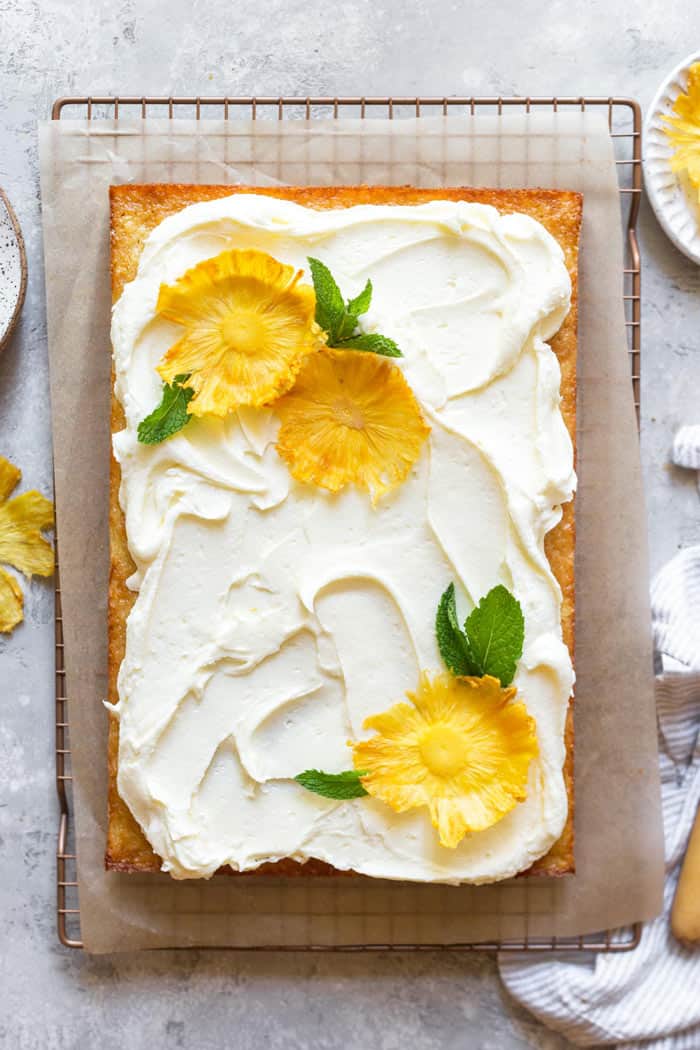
156, 251, 323, 416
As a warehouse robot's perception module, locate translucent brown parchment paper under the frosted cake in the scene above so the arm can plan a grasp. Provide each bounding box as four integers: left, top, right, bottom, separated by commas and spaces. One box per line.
40, 113, 663, 952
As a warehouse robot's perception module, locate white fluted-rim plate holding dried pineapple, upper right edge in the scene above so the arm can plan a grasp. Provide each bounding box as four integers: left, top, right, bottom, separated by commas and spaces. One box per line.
643, 51, 700, 264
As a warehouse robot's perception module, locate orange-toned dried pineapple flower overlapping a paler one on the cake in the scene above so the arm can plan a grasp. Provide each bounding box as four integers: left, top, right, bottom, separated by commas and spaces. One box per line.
274, 349, 430, 500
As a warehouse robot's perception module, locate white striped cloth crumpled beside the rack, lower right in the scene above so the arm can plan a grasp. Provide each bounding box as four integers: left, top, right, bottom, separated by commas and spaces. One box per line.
499, 426, 700, 1050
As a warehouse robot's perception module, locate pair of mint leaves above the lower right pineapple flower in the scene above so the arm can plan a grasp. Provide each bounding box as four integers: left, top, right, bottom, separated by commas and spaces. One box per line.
436, 584, 525, 686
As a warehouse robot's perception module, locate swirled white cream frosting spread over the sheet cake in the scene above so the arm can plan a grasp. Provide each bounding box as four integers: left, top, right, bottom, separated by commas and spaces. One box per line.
112, 194, 575, 883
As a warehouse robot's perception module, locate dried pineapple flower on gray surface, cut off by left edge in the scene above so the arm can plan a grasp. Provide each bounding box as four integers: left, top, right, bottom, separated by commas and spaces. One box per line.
0, 456, 54, 632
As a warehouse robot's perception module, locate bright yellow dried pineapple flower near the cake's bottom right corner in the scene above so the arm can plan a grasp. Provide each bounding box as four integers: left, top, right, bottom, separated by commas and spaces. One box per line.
353, 673, 538, 848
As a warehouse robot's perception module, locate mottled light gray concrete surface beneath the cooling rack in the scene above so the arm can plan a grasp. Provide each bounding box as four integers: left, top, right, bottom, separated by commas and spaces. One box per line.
0, 0, 700, 1050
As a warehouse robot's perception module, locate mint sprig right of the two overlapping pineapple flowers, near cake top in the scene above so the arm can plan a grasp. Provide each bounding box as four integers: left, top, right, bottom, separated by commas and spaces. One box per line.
309, 256, 403, 357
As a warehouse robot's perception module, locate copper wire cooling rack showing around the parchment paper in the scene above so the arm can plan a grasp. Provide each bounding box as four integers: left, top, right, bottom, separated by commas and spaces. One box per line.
51, 96, 642, 952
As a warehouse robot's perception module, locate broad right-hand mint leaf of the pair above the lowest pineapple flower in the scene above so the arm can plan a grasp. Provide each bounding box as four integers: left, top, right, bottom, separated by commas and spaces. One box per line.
464, 584, 525, 686
